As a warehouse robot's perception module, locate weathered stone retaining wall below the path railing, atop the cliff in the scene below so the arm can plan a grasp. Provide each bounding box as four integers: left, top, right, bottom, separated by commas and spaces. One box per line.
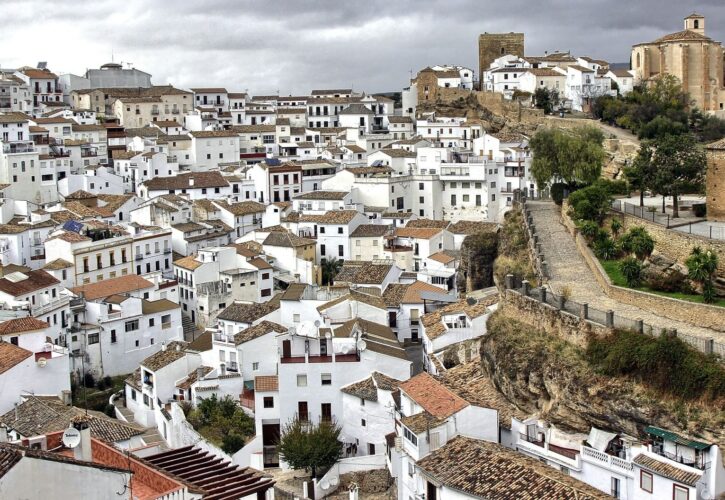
498, 290, 611, 349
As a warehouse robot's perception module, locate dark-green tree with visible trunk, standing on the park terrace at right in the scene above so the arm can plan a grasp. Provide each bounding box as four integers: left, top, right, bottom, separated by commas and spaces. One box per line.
651, 134, 707, 218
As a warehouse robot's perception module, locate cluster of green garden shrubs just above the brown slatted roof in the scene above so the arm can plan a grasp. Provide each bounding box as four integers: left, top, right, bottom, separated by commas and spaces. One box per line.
181, 394, 255, 455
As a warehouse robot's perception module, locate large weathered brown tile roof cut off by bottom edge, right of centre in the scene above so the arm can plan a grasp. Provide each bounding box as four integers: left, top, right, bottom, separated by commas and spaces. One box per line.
416, 436, 611, 500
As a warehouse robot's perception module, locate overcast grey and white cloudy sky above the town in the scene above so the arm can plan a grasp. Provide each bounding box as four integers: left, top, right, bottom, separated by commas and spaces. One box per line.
0, 0, 725, 95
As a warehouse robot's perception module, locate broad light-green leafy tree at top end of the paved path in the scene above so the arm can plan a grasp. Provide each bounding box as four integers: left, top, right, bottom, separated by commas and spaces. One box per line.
530, 126, 605, 186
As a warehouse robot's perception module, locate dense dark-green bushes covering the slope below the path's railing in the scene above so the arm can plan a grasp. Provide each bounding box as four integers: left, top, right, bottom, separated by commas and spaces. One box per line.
586, 330, 725, 400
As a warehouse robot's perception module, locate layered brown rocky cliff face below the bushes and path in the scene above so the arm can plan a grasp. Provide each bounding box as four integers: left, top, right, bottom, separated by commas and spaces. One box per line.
481, 313, 725, 446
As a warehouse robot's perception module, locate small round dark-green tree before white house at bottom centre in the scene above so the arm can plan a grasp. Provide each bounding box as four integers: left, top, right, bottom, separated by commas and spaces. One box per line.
277, 418, 342, 478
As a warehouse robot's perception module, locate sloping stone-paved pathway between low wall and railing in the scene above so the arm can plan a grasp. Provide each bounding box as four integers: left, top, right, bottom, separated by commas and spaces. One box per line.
526, 201, 725, 342
